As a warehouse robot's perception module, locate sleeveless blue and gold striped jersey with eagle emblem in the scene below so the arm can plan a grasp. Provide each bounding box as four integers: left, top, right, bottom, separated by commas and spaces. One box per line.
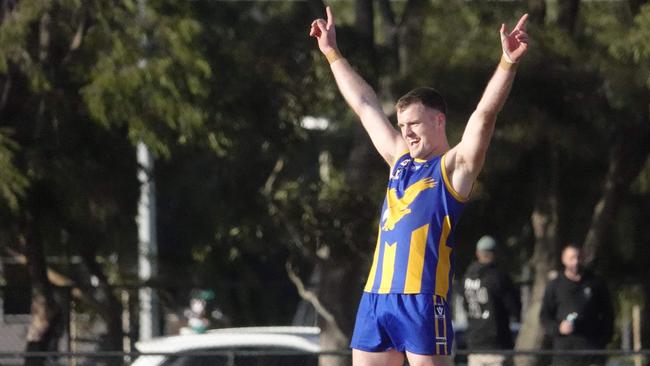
364, 153, 465, 299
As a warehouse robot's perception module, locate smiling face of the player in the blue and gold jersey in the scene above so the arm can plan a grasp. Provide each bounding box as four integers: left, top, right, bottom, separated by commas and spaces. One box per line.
397, 103, 445, 159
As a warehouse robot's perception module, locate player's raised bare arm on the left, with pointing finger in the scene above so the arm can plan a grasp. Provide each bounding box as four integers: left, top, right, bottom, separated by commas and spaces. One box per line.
309, 6, 407, 165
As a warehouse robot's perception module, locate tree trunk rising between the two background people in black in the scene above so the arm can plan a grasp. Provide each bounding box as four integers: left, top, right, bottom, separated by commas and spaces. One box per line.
515, 143, 559, 366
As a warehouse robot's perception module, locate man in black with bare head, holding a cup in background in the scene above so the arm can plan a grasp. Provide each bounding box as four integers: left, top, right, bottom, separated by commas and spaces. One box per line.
540, 244, 614, 366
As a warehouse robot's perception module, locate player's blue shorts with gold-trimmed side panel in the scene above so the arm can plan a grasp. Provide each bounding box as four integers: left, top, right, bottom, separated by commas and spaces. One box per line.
350, 292, 454, 355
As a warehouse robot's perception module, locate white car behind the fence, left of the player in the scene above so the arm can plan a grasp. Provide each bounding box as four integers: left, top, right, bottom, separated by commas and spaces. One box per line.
131, 327, 320, 366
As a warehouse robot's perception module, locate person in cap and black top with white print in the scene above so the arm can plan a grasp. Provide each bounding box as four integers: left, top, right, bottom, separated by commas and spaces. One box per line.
463, 235, 521, 366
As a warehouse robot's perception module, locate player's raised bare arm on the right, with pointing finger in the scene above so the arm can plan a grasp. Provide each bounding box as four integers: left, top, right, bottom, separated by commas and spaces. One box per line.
445, 14, 528, 196
